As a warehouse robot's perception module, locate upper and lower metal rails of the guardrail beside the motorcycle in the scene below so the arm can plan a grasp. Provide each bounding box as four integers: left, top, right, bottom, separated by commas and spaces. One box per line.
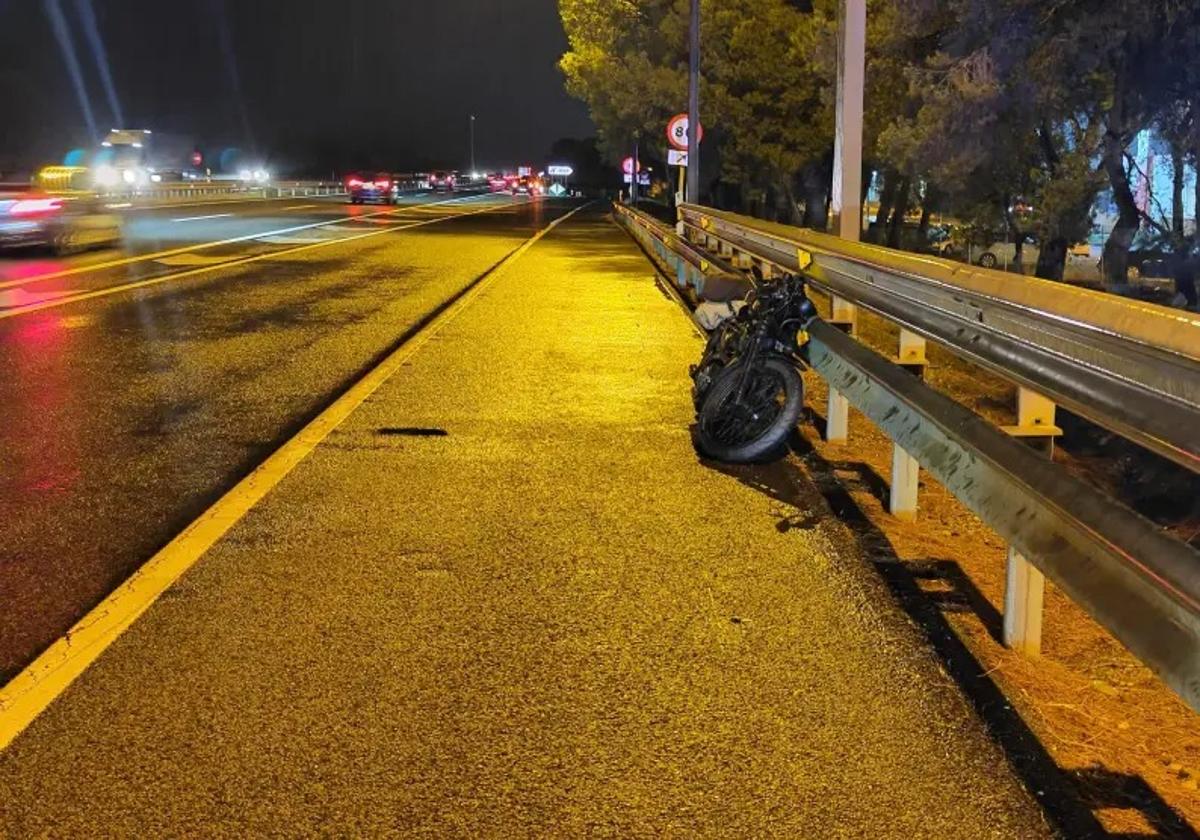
617, 200, 1200, 710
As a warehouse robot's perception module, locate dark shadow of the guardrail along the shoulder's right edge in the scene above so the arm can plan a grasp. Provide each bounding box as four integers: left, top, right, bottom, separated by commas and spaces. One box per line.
703, 433, 1200, 840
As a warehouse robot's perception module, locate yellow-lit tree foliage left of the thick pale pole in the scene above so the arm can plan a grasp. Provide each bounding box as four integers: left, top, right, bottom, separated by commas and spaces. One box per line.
559, 0, 834, 219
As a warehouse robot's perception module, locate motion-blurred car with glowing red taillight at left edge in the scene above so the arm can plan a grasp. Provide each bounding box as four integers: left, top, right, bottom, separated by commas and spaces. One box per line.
0, 184, 121, 256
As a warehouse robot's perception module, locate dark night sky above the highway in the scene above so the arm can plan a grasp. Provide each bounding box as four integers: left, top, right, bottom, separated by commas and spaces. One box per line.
0, 0, 593, 170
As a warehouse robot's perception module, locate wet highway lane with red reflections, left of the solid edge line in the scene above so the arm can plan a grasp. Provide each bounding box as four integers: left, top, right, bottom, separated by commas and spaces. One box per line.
0, 196, 571, 683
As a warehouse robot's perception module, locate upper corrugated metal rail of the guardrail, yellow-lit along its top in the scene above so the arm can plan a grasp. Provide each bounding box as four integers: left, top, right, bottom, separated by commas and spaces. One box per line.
680, 205, 1200, 472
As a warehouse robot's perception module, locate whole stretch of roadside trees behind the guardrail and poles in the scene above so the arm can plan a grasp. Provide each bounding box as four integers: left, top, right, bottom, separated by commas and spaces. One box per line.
559, 0, 1200, 290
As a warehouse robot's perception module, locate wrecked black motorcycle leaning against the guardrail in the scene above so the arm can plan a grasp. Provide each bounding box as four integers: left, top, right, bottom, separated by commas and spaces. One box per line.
690, 275, 816, 463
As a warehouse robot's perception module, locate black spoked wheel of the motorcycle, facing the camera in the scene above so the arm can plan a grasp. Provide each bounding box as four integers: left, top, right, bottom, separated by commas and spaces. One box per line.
697, 358, 804, 463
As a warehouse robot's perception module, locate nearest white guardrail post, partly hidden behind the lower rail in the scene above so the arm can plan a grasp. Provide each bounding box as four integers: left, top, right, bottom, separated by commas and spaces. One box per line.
1004, 388, 1062, 656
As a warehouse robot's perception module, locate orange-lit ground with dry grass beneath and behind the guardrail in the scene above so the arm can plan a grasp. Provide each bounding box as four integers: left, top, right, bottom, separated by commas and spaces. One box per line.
799, 298, 1200, 836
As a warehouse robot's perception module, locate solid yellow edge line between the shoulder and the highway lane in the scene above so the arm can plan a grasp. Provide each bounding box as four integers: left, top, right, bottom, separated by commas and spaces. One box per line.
0, 205, 586, 751
